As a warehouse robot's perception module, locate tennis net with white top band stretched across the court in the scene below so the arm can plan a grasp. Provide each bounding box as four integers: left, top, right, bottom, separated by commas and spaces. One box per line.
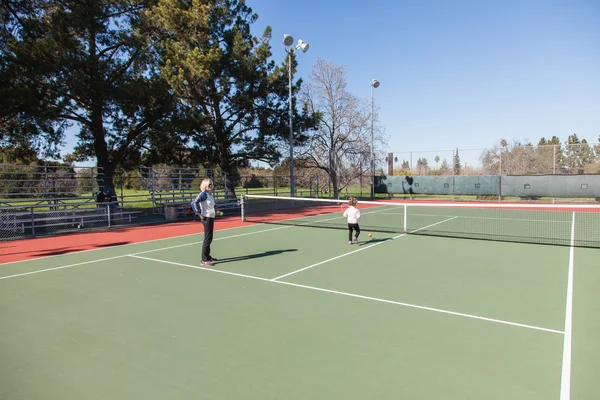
242, 195, 600, 247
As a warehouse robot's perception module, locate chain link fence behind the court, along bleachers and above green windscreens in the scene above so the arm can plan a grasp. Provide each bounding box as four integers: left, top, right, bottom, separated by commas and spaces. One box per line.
0, 143, 600, 240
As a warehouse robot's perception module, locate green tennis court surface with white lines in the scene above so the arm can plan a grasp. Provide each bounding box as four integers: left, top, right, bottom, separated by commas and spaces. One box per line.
0, 198, 600, 400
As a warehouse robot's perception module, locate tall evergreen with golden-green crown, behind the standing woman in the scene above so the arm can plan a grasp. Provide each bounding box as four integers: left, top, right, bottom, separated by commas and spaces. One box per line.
147, 0, 314, 196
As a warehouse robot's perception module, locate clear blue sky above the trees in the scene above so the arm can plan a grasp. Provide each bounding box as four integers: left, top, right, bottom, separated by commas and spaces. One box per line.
62, 0, 600, 168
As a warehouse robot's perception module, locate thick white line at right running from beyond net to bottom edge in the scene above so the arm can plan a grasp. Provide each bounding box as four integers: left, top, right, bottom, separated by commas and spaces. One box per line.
560, 212, 575, 400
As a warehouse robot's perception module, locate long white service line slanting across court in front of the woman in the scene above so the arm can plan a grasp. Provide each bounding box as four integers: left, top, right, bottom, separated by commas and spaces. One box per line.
131, 256, 564, 335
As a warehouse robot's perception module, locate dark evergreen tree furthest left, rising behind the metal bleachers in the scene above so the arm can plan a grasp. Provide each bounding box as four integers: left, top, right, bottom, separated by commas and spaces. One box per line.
1, 0, 172, 192
